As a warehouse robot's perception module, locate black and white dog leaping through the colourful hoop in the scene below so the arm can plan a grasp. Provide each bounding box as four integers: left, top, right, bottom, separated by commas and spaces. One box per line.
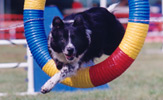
41, 4, 125, 93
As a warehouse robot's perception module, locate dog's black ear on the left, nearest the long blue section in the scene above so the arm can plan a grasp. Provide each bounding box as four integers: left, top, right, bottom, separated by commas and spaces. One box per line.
52, 16, 64, 29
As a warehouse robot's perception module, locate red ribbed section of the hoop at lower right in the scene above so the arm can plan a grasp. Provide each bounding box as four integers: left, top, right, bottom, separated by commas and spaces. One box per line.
90, 48, 134, 86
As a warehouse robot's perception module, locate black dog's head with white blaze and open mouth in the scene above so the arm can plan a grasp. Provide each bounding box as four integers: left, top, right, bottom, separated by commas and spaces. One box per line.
50, 16, 91, 62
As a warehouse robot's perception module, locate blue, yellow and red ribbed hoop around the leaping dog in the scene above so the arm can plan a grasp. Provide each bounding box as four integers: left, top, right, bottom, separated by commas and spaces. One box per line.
24, 0, 150, 88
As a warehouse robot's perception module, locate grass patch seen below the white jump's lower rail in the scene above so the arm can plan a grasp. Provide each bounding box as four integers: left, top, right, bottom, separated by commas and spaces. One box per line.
0, 68, 27, 93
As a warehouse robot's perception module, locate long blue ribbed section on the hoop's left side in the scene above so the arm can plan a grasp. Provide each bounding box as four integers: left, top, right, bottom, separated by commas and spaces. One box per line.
24, 10, 51, 69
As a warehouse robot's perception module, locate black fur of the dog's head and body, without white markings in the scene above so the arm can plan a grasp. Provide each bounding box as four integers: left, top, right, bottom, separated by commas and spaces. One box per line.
48, 7, 125, 69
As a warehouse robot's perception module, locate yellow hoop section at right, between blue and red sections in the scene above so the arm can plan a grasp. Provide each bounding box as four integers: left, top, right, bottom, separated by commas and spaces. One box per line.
119, 22, 149, 59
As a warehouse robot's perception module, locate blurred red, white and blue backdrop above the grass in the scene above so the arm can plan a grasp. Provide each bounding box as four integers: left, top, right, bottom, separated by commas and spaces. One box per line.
0, 0, 162, 41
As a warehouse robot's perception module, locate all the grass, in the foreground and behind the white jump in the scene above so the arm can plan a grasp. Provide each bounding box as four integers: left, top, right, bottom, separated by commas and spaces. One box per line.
0, 43, 163, 100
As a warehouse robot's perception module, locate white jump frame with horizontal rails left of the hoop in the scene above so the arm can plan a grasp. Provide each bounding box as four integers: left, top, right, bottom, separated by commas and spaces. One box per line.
0, 39, 38, 96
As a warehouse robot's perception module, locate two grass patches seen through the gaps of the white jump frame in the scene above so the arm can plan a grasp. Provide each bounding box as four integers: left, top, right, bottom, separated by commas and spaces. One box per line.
0, 45, 27, 93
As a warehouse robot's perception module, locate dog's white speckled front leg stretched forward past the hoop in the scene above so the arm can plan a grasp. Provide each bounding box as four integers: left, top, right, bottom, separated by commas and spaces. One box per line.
41, 72, 61, 94
